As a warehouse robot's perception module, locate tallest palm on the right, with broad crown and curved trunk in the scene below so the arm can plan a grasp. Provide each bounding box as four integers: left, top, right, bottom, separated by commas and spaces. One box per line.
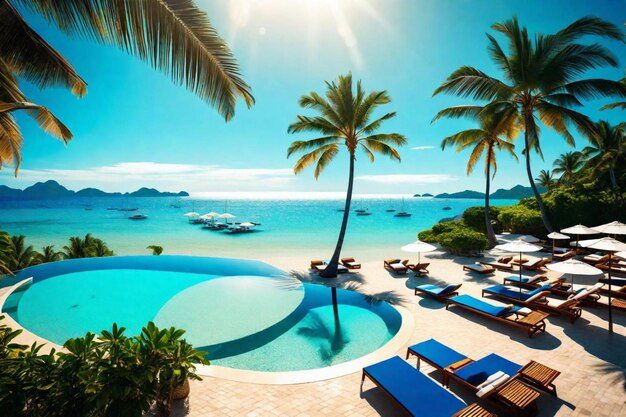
433, 17, 626, 232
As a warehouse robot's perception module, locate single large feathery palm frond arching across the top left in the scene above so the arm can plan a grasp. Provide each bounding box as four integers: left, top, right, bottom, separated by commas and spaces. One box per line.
13, 0, 254, 120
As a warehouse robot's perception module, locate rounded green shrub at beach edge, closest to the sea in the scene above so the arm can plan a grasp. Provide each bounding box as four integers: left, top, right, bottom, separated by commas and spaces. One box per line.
418, 219, 488, 255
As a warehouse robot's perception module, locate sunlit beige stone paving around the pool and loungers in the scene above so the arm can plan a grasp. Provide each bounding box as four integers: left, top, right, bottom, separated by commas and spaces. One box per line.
174, 253, 626, 417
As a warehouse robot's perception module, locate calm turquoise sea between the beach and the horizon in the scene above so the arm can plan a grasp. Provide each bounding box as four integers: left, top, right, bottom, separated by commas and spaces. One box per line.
0, 196, 516, 258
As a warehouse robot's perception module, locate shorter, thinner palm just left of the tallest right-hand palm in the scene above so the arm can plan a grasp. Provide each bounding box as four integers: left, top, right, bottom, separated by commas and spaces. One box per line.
435, 109, 519, 247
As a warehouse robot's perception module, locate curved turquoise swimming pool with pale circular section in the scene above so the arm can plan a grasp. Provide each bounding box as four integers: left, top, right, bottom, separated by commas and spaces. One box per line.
4, 256, 401, 371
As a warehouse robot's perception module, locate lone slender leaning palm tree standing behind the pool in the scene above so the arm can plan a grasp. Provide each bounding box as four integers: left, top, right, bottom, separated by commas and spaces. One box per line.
287, 74, 407, 278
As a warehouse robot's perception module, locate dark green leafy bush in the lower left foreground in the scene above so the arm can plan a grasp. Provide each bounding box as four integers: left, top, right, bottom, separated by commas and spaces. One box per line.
0, 317, 208, 417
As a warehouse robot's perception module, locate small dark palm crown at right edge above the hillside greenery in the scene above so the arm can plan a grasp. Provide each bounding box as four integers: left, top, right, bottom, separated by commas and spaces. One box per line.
583, 120, 626, 188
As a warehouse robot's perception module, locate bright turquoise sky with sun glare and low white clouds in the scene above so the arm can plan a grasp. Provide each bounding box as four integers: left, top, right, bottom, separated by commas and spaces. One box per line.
0, 0, 626, 194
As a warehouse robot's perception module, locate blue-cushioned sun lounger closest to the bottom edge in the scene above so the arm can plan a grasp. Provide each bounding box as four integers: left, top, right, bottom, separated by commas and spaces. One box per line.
361, 356, 495, 417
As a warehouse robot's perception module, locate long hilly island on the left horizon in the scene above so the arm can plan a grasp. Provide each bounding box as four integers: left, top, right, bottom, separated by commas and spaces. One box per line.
0, 180, 189, 200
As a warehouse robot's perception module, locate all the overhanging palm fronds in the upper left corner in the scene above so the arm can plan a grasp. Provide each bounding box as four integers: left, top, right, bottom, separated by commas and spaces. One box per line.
0, 0, 254, 173
